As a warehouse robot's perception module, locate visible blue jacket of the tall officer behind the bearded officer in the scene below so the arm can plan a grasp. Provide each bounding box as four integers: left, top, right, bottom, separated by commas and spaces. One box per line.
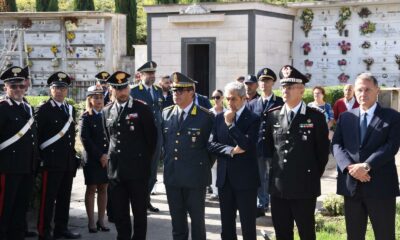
131, 83, 164, 128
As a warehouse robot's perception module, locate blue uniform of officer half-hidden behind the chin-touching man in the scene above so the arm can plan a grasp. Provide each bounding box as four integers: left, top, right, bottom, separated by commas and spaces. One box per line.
248, 94, 284, 211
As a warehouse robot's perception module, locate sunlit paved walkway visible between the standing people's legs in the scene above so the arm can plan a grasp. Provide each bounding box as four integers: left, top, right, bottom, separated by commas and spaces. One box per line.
29, 158, 400, 240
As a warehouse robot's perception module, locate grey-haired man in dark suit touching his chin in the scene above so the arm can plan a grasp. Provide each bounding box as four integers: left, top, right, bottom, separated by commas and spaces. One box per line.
209, 82, 260, 240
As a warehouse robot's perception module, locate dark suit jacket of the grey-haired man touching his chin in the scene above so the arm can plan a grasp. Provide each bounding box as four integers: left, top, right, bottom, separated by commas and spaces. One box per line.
208, 107, 260, 190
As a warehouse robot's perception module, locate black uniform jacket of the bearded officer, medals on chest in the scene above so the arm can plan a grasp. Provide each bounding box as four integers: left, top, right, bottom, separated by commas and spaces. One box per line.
103, 97, 157, 180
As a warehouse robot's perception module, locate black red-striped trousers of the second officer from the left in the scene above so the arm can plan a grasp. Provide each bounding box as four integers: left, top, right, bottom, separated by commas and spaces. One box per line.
38, 170, 75, 237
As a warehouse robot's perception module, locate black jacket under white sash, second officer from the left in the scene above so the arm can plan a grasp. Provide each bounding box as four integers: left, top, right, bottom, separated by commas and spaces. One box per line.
35, 98, 79, 171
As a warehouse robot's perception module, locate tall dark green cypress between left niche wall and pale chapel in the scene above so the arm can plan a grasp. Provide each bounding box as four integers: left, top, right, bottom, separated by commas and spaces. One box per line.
115, 0, 137, 56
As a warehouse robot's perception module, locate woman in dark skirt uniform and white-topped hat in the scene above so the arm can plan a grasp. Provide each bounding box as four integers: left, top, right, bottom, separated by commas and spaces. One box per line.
80, 86, 110, 233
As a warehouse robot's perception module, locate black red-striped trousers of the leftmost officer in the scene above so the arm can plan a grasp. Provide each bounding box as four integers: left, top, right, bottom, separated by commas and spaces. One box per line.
0, 174, 33, 240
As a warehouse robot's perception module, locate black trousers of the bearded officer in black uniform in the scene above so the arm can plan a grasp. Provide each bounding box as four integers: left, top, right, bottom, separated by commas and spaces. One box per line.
110, 179, 148, 240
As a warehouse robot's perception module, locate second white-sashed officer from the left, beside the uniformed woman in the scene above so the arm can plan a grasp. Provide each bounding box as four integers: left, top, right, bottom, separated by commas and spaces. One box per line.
35, 72, 81, 240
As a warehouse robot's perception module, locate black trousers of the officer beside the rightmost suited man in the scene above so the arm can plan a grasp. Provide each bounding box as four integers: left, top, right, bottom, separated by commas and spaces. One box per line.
271, 195, 317, 240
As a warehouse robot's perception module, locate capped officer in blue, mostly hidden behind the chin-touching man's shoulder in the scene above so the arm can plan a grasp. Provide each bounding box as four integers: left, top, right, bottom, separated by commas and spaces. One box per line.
248, 68, 283, 217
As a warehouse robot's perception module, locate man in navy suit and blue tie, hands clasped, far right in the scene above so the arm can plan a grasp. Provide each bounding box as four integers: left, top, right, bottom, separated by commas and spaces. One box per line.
332, 73, 400, 240
